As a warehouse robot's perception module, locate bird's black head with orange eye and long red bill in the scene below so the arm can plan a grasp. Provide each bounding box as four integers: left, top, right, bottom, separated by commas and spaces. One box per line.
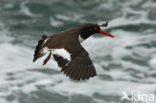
80, 23, 114, 39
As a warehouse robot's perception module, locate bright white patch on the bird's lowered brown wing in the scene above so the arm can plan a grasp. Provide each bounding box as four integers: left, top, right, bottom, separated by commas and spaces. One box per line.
51, 48, 71, 61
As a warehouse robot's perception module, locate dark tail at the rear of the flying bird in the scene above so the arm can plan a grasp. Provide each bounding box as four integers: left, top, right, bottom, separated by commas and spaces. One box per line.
33, 35, 48, 62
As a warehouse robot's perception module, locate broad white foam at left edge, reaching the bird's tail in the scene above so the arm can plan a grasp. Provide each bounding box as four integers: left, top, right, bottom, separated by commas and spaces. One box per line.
0, 43, 59, 72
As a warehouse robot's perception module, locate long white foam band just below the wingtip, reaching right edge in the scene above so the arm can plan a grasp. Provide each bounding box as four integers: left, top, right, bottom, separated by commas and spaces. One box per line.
48, 78, 156, 96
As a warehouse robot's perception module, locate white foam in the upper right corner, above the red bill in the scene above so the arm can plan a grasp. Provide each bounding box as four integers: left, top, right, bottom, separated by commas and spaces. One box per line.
99, 0, 156, 28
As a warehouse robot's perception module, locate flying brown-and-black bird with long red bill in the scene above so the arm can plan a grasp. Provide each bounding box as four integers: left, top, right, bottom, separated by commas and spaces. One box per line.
33, 22, 115, 80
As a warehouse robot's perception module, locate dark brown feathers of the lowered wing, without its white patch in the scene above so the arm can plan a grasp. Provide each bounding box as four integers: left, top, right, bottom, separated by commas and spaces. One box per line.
53, 44, 97, 80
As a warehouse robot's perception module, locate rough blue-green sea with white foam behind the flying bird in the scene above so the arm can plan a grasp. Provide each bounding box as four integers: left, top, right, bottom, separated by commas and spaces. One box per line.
0, 0, 156, 103
